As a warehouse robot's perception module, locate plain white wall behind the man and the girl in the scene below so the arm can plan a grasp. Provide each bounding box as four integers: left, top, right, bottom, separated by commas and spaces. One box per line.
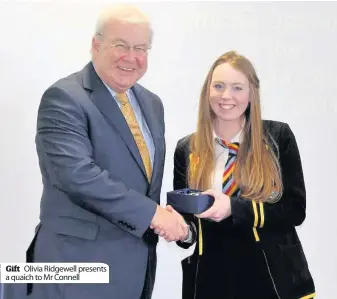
0, 0, 337, 299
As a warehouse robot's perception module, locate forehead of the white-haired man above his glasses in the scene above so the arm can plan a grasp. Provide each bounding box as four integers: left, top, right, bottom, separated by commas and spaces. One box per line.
103, 19, 152, 45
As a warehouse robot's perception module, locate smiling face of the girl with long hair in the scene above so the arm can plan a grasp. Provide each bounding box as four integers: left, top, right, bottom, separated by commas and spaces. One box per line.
209, 63, 250, 122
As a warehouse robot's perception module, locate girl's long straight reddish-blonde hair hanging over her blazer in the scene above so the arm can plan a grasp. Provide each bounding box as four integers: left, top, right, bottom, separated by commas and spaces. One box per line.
188, 51, 283, 202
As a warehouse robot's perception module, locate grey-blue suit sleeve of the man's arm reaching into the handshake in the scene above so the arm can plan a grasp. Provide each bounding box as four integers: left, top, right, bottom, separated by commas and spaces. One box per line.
36, 86, 157, 238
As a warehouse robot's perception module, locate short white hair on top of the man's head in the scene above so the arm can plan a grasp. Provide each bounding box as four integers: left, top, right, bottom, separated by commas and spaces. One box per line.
94, 4, 153, 44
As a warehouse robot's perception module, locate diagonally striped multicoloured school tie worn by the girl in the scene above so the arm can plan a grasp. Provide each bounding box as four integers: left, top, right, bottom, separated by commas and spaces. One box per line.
216, 138, 240, 196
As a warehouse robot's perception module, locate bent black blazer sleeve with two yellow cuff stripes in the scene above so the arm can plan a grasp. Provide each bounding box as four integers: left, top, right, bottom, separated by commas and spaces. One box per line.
231, 124, 306, 229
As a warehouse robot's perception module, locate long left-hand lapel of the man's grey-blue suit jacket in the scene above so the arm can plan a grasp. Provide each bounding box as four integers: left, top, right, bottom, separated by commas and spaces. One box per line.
82, 63, 146, 176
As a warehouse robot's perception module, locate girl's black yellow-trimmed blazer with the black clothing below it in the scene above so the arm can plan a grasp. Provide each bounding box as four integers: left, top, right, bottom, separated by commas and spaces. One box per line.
174, 121, 315, 299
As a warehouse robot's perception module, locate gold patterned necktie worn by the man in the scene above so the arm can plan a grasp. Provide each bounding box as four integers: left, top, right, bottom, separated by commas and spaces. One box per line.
116, 93, 152, 182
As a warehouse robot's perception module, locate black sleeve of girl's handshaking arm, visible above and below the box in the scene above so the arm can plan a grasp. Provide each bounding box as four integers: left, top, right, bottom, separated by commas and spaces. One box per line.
173, 138, 198, 249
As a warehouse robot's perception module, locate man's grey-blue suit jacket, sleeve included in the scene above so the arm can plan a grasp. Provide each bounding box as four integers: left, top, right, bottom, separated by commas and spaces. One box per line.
7, 63, 165, 299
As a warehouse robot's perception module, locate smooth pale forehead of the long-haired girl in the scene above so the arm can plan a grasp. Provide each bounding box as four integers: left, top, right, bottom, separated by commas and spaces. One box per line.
212, 63, 249, 85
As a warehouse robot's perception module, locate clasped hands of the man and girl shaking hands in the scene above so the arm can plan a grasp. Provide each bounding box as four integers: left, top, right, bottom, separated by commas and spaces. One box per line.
150, 206, 189, 242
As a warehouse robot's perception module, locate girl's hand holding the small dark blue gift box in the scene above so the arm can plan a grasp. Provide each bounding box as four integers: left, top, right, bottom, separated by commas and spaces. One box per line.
195, 189, 232, 222
